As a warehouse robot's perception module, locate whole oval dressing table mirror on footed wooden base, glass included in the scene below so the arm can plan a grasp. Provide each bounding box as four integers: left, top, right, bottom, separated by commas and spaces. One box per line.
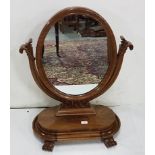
19, 7, 133, 151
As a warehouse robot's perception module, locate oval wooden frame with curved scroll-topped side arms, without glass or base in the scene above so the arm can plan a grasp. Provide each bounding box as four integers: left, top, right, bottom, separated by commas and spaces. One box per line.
20, 7, 133, 108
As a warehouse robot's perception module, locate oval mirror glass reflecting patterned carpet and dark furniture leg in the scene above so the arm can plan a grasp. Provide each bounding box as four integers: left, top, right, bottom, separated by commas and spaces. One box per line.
42, 14, 108, 95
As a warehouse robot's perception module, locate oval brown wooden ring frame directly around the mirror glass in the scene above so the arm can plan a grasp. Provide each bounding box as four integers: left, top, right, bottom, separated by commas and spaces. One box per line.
36, 7, 117, 103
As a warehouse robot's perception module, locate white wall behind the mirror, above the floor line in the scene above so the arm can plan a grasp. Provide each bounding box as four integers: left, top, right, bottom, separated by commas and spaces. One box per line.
10, 0, 145, 107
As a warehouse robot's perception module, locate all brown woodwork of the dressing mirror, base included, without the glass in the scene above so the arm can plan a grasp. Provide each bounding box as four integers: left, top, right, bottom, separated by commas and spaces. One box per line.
19, 7, 133, 151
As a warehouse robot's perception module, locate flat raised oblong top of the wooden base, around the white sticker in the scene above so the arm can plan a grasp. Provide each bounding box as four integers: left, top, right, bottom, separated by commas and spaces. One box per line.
38, 105, 115, 132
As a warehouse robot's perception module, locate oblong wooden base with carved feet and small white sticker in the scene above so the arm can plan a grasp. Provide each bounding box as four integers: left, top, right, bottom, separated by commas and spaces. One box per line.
33, 105, 120, 151
